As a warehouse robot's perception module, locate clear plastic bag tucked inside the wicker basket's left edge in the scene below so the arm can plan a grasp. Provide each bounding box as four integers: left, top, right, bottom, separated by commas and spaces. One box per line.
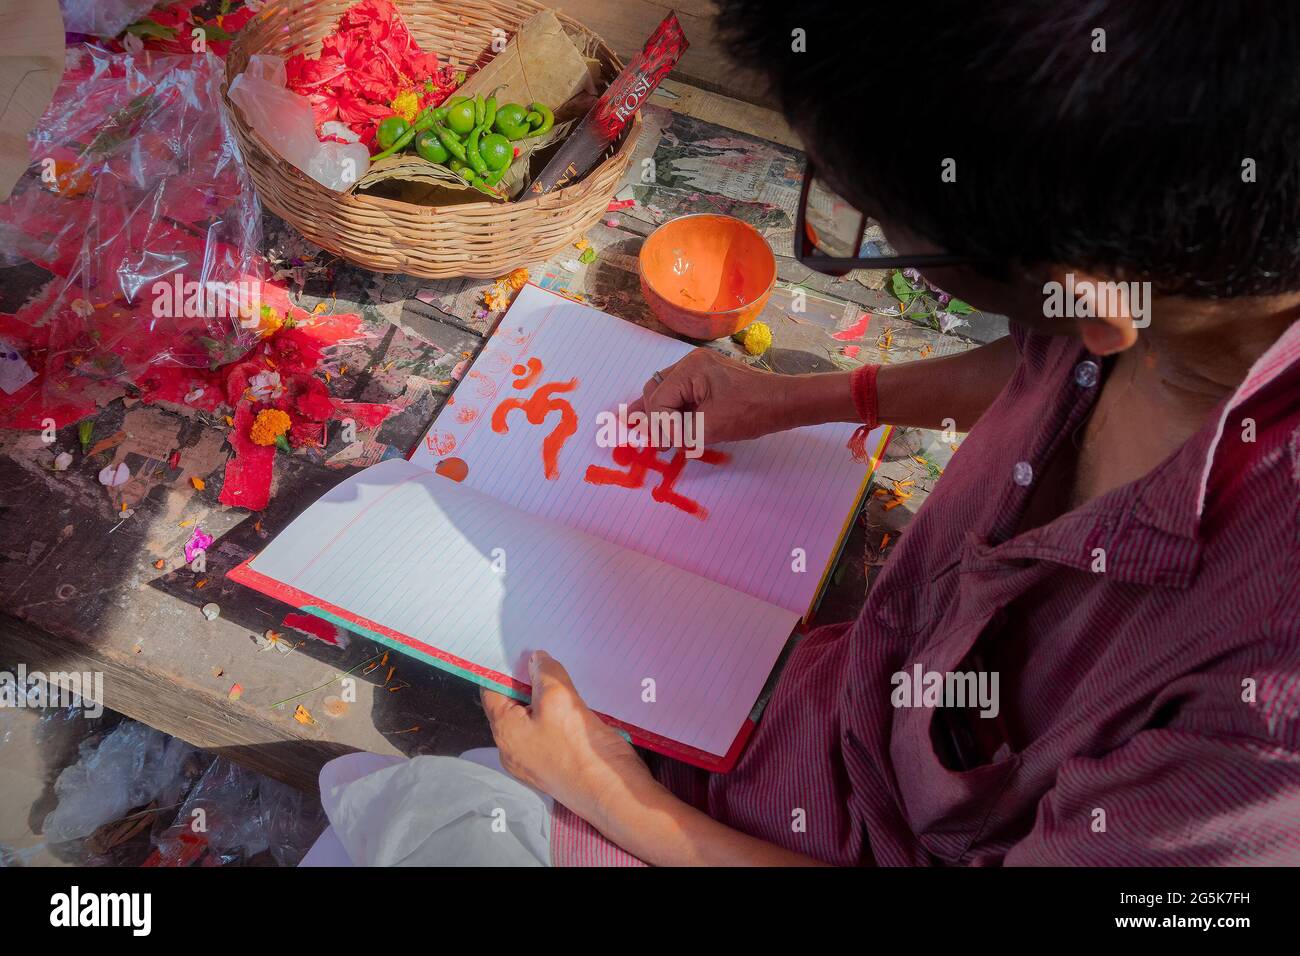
230, 53, 371, 193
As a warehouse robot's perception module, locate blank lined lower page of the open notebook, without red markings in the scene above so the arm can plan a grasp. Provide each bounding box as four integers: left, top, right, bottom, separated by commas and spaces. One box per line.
250, 460, 797, 756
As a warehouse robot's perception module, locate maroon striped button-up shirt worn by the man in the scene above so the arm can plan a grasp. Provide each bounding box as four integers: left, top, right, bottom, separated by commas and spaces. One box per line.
553, 323, 1300, 865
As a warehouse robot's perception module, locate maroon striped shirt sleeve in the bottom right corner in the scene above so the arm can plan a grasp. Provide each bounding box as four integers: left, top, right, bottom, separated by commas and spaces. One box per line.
1002, 730, 1300, 866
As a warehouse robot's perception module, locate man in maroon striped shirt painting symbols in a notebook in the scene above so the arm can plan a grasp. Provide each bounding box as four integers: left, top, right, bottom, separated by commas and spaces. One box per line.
309, 0, 1300, 865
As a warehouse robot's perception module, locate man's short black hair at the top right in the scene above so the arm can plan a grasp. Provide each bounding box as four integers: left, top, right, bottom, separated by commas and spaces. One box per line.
718, 0, 1300, 297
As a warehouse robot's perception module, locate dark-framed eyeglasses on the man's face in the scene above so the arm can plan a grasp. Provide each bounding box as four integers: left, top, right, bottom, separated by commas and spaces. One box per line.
794, 161, 984, 276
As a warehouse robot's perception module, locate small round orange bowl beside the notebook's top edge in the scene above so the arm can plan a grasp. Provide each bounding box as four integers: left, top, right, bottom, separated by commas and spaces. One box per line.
638, 213, 776, 339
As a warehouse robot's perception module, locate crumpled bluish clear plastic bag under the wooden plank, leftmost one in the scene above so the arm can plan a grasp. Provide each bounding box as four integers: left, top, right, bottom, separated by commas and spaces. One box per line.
43, 721, 194, 843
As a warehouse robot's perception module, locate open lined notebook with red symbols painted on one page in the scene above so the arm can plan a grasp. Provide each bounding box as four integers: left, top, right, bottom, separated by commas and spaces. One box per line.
230, 285, 888, 770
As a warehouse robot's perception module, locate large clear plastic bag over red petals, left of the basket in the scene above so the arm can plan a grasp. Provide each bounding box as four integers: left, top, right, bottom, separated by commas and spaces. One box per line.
0, 44, 268, 428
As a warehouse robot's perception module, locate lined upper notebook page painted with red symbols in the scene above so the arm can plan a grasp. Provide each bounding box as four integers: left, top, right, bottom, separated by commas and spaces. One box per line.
412, 285, 884, 614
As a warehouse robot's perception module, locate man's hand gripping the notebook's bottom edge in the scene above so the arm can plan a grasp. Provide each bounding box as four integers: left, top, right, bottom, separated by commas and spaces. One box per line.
480, 650, 653, 826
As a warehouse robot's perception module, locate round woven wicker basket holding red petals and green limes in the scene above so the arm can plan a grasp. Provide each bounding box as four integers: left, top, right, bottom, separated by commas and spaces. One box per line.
222, 0, 641, 278
